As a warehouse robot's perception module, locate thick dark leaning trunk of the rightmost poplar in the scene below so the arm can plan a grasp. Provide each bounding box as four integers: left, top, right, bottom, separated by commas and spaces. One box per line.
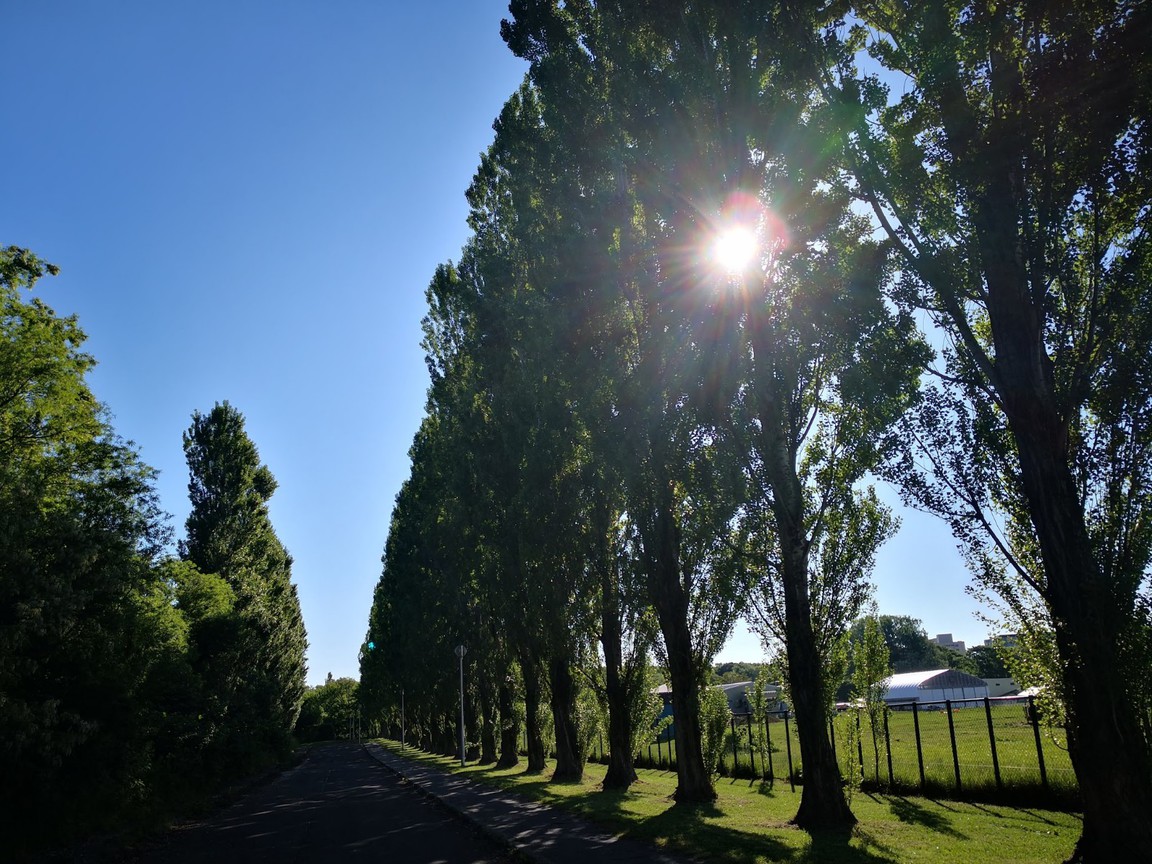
975, 172, 1152, 864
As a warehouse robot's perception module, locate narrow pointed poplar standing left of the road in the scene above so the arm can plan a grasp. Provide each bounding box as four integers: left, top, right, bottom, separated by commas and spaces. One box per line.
181, 402, 308, 764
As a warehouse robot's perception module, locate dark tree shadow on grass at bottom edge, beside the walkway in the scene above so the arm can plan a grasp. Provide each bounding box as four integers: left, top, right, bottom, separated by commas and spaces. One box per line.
624, 804, 895, 864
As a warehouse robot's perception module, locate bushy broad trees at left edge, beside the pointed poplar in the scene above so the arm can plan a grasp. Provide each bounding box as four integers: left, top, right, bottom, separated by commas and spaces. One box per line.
0, 247, 247, 849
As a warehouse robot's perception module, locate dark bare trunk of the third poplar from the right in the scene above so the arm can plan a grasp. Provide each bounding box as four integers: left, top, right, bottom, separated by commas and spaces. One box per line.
644, 499, 717, 804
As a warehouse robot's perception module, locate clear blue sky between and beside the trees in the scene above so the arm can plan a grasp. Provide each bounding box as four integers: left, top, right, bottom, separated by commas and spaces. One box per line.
0, 0, 986, 683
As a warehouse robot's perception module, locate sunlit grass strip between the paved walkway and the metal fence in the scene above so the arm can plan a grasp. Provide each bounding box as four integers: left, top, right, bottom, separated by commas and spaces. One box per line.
380, 741, 1081, 864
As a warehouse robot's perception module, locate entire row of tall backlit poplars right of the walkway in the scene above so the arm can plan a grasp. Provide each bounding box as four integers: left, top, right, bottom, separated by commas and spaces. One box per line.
362, 0, 1152, 862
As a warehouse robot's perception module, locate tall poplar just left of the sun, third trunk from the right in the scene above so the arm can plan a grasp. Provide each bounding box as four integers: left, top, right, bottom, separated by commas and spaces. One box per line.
503, 2, 740, 803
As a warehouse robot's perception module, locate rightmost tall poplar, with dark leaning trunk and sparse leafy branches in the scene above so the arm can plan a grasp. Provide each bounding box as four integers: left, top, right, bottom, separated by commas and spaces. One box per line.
812, 0, 1152, 862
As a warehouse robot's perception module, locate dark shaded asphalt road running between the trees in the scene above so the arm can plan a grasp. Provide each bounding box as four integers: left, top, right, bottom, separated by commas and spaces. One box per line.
132, 744, 511, 864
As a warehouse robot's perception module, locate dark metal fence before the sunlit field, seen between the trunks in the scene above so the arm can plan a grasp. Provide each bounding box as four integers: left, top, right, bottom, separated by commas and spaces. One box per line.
591, 698, 1078, 806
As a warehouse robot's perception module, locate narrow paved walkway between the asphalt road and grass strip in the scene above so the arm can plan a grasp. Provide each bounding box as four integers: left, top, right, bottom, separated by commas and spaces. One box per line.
364, 743, 691, 864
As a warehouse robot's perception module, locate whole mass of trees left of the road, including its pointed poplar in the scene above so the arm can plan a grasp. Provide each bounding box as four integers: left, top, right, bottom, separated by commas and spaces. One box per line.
0, 247, 305, 850
